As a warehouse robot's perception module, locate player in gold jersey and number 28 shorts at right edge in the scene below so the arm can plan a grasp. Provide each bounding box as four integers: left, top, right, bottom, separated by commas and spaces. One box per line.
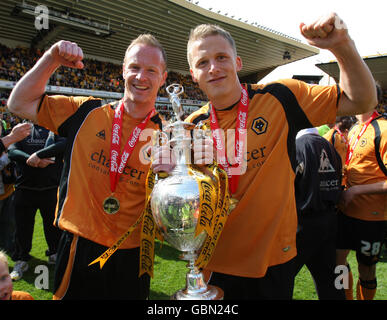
337, 85, 387, 300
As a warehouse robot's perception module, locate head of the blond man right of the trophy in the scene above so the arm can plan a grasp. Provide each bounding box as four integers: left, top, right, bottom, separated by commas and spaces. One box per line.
189, 35, 242, 109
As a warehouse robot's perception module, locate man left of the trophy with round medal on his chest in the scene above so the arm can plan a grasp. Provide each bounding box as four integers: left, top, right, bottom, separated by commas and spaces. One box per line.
9, 34, 167, 299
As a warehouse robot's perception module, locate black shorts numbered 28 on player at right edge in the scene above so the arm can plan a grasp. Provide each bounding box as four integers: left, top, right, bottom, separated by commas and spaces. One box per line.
336, 212, 386, 266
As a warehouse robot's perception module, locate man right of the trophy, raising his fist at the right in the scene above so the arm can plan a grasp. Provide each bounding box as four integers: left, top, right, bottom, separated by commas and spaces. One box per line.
180, 14, 376, 299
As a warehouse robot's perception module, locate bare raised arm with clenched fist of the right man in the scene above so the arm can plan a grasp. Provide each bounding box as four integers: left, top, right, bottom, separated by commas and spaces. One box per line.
300, 13, 377, 116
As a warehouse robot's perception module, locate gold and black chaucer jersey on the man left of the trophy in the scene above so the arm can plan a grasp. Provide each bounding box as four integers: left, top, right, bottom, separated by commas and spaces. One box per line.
38, 96, 161, 248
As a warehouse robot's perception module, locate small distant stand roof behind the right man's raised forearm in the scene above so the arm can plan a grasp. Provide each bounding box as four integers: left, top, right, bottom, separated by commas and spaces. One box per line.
316, 55, 387, 91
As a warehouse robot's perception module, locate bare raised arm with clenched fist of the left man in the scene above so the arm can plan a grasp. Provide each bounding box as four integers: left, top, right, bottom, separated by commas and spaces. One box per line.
8, 40, 83, 122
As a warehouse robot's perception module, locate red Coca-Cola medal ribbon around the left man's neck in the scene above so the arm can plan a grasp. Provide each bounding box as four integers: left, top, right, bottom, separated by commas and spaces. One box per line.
110, 101, 155, 193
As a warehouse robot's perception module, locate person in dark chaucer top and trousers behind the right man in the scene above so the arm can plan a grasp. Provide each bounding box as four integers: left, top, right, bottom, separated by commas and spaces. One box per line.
294, 128, 345, 300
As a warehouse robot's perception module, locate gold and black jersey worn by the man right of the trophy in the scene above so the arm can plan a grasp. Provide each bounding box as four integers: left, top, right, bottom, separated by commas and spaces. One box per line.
185, 80, 340, 277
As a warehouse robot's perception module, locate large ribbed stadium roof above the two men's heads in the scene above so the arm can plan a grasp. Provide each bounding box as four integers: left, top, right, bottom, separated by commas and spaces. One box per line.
0, 0, 319, 81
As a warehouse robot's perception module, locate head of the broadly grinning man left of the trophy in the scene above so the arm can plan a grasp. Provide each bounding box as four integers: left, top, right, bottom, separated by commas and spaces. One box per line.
123, 44, 167, 114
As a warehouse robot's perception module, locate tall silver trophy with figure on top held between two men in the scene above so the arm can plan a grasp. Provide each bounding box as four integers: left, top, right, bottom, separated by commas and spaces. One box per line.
151, 84, 223, 300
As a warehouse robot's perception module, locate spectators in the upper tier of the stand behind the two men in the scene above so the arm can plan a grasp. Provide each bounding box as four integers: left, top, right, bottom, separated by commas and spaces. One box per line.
0, 44, 207, 101
